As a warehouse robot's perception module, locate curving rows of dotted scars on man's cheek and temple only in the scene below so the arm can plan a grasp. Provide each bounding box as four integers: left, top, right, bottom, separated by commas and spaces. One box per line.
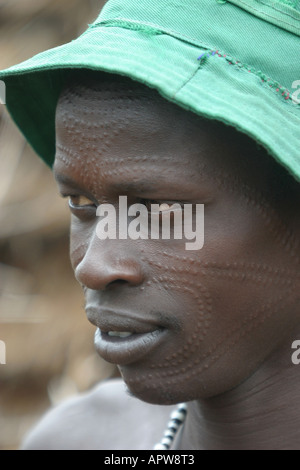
129, 169, 300, 389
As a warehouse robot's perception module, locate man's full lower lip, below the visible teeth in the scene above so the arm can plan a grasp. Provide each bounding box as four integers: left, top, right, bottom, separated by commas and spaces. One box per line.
95, 328, 166, 366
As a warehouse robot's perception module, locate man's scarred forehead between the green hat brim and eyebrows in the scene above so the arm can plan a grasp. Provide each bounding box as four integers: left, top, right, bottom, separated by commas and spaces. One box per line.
55, 76, 292, 200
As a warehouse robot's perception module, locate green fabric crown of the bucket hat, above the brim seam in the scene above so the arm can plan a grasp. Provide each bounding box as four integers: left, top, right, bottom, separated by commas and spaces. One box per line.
91, 0, 300, 90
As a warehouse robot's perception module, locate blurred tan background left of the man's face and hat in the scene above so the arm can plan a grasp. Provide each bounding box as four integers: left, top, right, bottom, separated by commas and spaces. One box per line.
0, 0, 116, 450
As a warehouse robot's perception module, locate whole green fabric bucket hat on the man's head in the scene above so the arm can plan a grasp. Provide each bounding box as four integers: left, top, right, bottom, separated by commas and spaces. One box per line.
0, 0, 300, 181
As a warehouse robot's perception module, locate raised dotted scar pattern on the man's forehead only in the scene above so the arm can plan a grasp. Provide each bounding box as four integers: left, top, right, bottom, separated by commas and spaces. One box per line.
56, 84, 184, 195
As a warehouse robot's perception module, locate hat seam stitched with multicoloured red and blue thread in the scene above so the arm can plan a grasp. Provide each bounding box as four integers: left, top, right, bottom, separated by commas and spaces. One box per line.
198, 50, 298, 107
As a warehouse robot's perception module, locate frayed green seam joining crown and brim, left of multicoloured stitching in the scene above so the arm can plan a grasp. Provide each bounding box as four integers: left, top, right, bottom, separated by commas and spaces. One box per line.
82, 17, 216, 49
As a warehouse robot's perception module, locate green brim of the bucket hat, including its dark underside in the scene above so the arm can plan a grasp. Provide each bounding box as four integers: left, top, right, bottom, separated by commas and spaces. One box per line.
0, 24, 300, 181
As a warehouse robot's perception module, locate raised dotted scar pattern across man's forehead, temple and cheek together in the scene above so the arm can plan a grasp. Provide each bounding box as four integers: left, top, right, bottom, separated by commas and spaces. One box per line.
57, 80, 300, 399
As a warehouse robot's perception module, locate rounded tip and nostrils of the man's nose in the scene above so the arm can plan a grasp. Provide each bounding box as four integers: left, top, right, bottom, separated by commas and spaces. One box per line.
75, 237, 144, 290
